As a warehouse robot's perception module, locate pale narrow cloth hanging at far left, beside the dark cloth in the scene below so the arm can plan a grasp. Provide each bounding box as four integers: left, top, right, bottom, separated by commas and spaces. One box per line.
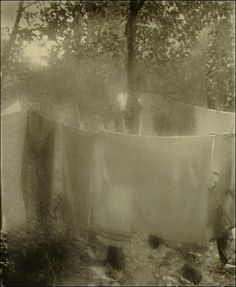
1, 111, 26, 231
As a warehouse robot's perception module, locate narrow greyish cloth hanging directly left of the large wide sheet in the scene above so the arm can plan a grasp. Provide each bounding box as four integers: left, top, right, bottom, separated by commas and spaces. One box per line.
62, 126, 94, 235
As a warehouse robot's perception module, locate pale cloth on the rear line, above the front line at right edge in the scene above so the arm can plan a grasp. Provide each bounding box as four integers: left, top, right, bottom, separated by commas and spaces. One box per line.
195, 107, 235, 135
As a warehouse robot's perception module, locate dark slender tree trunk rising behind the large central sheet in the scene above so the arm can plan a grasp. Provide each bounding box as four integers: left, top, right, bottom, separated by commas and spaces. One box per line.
125, 0, 145, 133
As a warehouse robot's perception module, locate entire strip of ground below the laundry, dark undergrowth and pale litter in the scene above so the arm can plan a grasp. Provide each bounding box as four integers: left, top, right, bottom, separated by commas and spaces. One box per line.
1, 230, 235, 286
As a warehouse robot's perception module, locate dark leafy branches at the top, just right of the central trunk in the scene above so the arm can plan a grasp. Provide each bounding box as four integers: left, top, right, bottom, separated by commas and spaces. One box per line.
137, 1, 232, 67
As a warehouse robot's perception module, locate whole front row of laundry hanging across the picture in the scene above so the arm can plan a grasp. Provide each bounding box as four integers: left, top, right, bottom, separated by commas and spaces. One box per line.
2, 106, 235, 250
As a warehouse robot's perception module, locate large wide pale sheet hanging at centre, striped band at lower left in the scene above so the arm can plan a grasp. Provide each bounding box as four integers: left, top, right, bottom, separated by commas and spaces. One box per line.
95, 131, 216, 246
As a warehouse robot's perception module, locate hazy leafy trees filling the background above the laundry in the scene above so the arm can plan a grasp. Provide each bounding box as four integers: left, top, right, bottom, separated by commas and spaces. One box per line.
3, 0, 234, 129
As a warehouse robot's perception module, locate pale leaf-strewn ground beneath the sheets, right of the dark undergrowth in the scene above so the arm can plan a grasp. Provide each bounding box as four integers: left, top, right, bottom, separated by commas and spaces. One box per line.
61, 234, 235, 286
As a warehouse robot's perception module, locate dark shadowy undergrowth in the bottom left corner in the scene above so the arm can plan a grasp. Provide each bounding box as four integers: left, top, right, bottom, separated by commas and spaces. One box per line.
3, 226, 87, 286
